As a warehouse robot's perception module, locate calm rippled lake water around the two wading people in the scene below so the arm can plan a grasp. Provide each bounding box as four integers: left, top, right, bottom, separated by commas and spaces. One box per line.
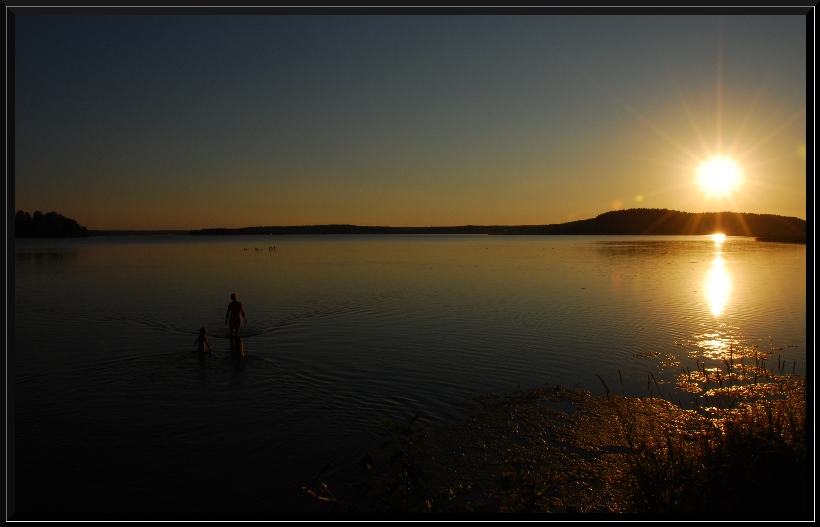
9, 236, 807, 512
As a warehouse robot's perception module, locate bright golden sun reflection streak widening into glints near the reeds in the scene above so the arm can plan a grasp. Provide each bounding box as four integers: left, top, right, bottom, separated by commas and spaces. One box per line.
635, 234, 805, 417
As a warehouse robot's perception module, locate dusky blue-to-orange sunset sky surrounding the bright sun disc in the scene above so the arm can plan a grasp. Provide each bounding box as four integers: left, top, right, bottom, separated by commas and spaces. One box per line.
11, 11, 814, 229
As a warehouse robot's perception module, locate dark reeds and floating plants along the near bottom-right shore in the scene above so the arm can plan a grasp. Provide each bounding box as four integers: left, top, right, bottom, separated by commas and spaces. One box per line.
302, 368, 814, 519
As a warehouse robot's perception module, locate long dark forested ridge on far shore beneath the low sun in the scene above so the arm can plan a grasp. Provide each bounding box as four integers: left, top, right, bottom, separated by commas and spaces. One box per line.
190, 209, 806, 237
